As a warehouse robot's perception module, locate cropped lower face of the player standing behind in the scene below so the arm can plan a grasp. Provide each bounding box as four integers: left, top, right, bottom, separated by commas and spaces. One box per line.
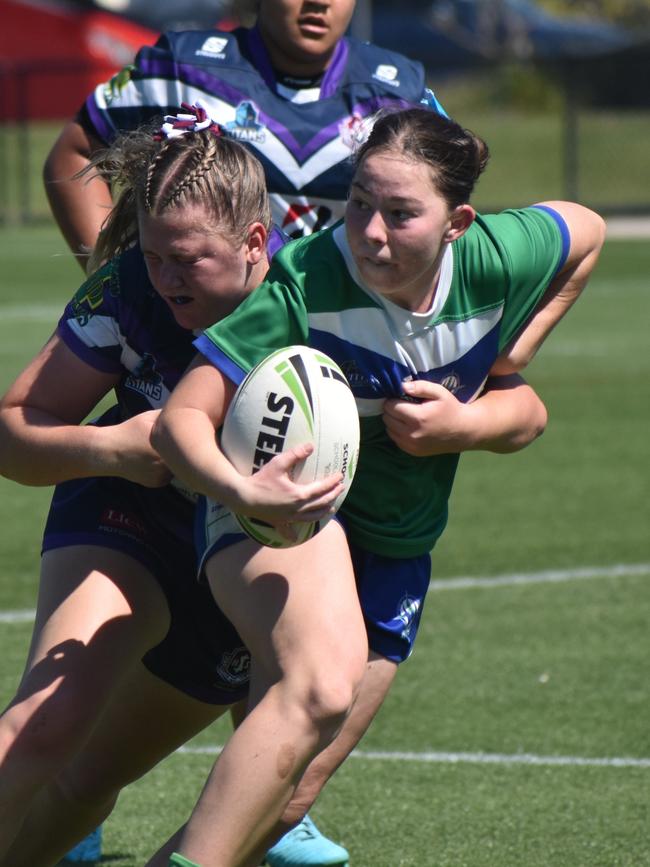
257, 0, 355, 76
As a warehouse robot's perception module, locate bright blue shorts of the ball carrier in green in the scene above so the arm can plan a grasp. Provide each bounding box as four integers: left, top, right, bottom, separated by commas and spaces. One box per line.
196, 497, 431, 663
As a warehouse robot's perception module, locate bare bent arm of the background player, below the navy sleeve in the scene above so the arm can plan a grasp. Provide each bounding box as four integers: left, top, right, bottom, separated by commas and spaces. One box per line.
43, 118, 112, 270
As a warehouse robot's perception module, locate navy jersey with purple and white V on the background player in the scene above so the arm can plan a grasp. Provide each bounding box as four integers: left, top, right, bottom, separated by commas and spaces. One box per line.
80, 28, 443, 237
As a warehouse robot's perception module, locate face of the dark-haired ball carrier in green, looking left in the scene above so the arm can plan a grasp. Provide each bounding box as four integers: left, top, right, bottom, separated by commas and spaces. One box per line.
345, 151, 474, 313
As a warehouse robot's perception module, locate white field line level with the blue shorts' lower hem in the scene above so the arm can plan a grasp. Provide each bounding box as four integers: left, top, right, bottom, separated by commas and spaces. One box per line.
0, 563, 650, 623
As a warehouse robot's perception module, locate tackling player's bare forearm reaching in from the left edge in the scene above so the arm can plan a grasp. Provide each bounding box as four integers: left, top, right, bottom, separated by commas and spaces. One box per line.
0, 406, 128, 486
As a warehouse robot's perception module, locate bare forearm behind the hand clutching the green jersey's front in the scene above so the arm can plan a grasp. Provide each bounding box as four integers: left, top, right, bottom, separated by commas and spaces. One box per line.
467, 374, 547, 454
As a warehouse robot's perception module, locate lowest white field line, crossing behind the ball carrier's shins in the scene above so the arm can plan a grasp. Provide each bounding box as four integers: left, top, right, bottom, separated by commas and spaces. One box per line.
177, 745, 650, 768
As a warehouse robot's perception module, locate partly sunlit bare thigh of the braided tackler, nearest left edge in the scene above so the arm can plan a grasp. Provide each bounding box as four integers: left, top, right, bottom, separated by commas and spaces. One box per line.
3, 546, 169, 760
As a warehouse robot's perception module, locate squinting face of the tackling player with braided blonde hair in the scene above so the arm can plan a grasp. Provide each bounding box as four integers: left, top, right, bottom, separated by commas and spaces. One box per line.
138, 205, 268, 330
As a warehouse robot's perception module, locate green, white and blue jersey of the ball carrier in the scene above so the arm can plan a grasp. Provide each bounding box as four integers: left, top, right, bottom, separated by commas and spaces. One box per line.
195, 207, 569, 557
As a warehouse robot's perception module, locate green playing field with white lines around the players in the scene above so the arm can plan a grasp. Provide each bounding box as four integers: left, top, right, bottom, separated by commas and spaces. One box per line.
0, 228, 650, 867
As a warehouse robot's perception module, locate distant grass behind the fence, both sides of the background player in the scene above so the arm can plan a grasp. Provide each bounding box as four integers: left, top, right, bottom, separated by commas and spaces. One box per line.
0, 107, 650, 222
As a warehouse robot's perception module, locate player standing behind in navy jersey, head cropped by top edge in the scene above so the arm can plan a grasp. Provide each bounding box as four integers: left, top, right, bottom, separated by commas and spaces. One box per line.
44, 0, 442, 272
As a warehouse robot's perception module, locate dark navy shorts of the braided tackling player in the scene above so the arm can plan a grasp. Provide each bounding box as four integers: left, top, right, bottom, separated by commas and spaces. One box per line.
43, 478, 250, 704
